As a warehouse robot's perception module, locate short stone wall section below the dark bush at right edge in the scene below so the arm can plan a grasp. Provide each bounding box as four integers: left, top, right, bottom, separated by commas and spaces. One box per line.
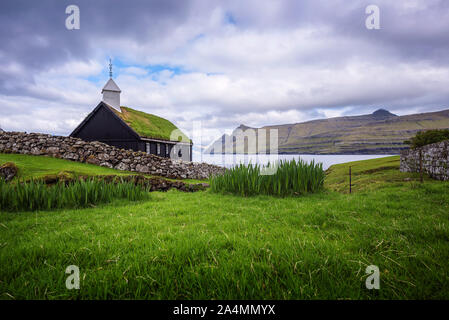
400, 140, 449, 181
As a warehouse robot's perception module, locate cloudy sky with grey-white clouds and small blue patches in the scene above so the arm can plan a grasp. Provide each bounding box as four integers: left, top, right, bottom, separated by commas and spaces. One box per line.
0, 0, 449, 150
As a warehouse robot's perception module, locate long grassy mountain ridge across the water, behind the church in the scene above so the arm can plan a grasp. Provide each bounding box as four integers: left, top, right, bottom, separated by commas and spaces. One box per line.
205, 109, 449, 154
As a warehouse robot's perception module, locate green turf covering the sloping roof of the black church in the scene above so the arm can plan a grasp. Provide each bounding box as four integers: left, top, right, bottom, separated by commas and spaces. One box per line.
116, 107, 190, 142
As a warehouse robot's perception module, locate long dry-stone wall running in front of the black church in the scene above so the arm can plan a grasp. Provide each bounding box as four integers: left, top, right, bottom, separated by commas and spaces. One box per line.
0, 132, 225, 179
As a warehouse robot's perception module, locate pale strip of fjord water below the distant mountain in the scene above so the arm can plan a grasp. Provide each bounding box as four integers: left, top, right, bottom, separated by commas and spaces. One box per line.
193, 153, 391, 170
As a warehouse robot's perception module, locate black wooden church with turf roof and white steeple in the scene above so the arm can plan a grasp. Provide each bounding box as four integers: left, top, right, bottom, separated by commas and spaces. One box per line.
70, 64, 193, 161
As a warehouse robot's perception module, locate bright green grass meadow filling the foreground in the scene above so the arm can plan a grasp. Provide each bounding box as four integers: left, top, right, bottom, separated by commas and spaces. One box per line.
0, 155, 449, 299
